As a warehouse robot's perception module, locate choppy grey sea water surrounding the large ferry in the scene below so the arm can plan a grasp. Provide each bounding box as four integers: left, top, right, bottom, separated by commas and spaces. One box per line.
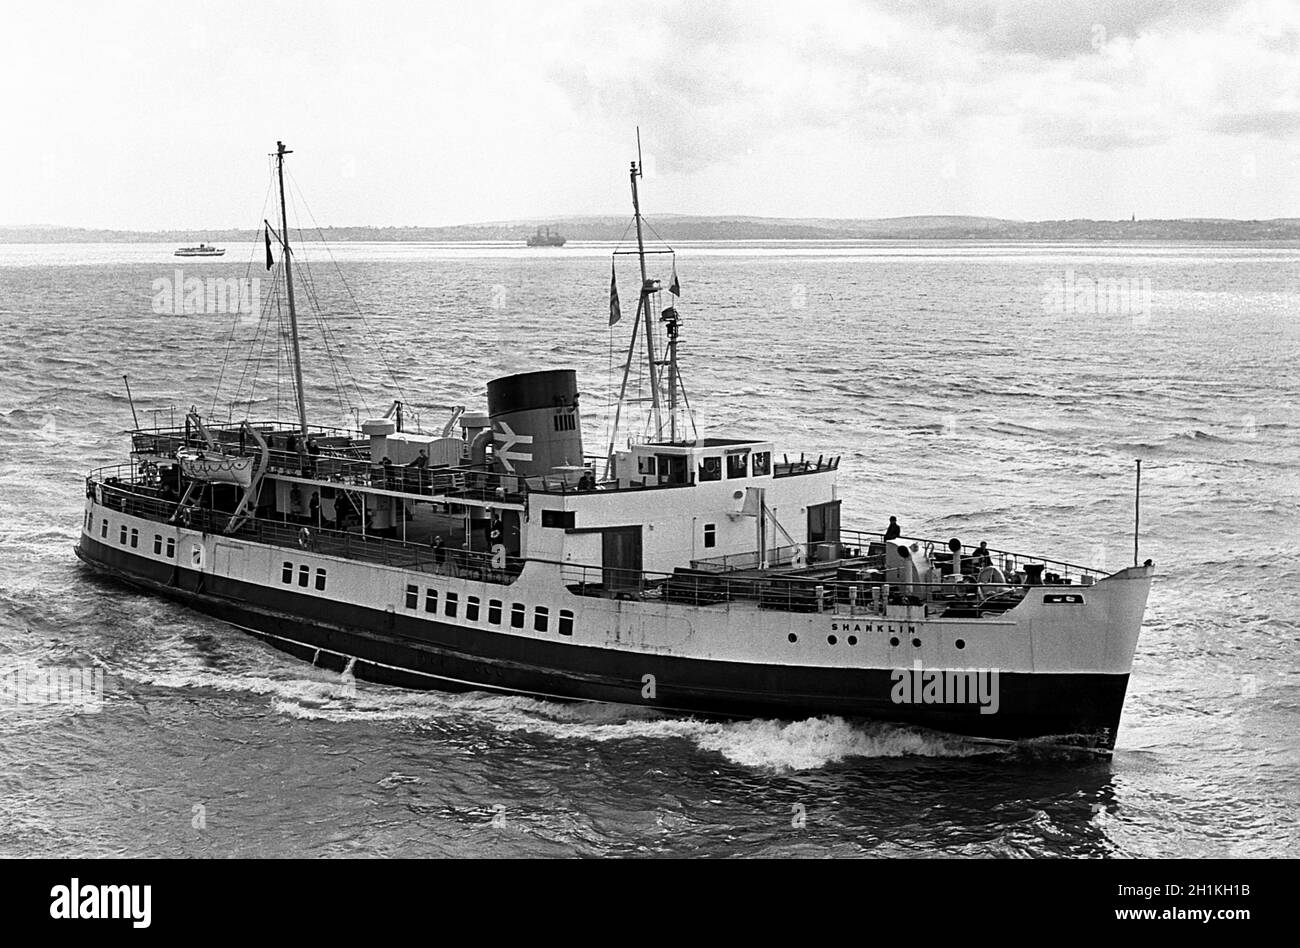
0, 244, 1300, 856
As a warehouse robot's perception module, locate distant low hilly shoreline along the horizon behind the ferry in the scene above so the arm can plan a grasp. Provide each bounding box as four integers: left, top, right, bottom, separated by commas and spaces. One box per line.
0, 216, 1300, 246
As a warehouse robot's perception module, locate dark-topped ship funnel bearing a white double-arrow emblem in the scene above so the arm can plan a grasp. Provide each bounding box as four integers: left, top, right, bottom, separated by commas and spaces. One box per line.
488, 369, 582, 477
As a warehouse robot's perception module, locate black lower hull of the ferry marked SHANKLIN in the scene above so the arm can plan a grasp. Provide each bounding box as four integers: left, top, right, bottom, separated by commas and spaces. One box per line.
77, 537, 1128, 750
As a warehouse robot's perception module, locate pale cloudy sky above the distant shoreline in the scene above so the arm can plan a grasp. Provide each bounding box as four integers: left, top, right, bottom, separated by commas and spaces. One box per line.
0, 0, 1300, 230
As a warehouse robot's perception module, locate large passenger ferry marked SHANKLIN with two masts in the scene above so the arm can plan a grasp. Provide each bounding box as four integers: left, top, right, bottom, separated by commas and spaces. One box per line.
77, 143, 1154, 752
